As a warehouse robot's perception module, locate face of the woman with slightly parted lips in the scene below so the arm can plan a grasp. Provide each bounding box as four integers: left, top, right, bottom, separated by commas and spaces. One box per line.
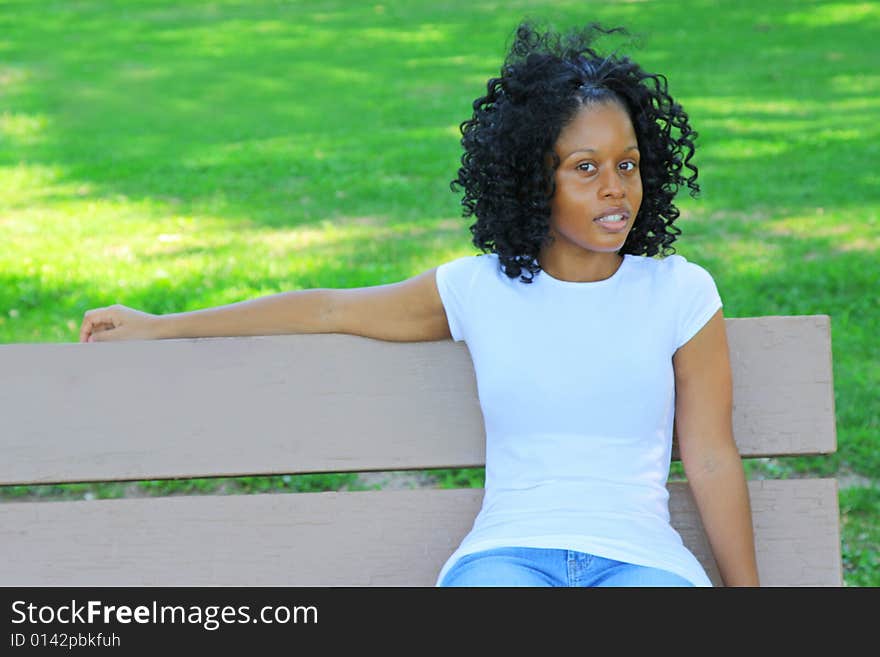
550, 101, 642, 256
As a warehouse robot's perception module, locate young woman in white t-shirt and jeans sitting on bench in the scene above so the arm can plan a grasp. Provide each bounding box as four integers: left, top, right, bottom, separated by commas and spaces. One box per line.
80, 23, 758, 586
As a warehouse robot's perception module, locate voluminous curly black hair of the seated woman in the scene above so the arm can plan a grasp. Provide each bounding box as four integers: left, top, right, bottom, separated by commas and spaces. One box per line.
450, 21, 699, 283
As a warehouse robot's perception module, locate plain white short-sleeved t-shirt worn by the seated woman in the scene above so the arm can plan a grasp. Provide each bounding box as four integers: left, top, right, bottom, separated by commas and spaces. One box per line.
437, 254, 722, 586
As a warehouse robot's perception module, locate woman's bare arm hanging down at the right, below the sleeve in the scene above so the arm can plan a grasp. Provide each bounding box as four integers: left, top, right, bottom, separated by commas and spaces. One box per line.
672, 309, 759, 586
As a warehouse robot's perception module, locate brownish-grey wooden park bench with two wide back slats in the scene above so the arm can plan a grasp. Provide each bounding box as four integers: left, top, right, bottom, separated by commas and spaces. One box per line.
0, 315, 842, 586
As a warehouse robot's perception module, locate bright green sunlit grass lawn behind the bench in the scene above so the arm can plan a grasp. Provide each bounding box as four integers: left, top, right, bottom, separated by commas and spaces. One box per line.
0, 0, 880, 586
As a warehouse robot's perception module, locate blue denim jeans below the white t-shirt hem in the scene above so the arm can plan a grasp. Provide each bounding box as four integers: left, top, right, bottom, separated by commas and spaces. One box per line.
440, 547, 693, 587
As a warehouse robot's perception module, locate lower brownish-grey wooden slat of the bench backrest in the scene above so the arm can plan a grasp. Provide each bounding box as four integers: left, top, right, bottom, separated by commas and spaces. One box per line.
0, 479, 842, 586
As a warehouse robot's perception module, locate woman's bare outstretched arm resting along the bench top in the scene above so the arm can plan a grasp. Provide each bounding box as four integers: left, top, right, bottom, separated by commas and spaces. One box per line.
79, 268, 452, 342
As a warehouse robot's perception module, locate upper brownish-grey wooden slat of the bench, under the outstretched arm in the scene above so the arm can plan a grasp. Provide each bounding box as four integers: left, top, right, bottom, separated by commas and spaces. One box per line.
0, 315, 836, 484
